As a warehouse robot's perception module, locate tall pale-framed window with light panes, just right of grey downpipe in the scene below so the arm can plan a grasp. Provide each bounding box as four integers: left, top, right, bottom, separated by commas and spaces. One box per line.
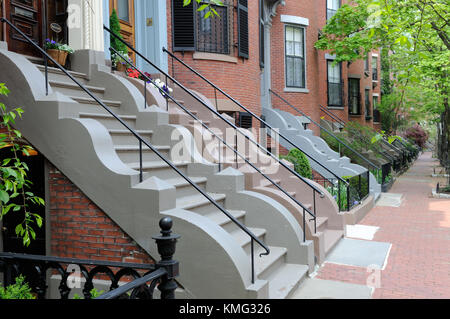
285, 25, 306, 88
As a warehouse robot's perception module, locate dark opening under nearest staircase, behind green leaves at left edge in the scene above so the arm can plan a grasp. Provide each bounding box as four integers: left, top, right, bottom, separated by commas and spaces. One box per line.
0, 148, 45, 255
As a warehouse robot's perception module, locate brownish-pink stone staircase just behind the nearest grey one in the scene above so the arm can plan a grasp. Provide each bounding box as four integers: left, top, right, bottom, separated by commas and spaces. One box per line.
125, 77, 344, 263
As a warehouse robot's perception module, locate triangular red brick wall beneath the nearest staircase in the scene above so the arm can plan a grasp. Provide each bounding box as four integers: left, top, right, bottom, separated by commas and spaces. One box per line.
48, 165, 153, 264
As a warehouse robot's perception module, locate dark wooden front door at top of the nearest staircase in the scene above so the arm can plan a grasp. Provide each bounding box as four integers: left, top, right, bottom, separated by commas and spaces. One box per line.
3, 0, 42, 56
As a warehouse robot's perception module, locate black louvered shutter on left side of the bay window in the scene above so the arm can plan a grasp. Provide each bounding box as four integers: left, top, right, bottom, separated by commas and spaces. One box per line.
172, 0, 195, 51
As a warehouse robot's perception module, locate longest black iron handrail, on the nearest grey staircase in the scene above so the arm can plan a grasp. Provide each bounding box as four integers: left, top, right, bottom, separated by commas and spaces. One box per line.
0, 18, 270, 282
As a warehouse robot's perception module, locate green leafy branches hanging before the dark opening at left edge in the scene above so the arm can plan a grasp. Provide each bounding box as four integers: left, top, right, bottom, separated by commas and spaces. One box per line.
0, 83, 45, 246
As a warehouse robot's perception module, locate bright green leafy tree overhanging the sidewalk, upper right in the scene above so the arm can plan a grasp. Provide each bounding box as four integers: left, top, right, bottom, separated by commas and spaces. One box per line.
316, 0, 450, 163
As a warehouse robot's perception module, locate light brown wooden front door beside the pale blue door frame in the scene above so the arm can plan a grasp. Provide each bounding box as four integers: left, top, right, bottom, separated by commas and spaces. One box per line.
109, 0, 135, 61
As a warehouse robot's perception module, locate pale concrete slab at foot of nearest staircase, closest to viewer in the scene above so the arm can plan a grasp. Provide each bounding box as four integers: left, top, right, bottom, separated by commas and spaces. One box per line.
291, 278, 372, 299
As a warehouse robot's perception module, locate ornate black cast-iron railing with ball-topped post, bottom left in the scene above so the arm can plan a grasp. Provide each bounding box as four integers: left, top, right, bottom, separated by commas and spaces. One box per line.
0, 217, 180, 299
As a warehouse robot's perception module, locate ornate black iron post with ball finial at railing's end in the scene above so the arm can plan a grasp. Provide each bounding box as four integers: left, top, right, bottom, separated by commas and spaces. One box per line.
152, 217, 180, 299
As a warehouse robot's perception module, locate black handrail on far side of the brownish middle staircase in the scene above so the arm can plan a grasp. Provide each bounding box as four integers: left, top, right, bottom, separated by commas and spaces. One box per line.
163, 48, 348, 193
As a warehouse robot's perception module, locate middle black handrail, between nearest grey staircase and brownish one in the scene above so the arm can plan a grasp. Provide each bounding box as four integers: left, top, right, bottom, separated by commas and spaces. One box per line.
110, 48, 316, 241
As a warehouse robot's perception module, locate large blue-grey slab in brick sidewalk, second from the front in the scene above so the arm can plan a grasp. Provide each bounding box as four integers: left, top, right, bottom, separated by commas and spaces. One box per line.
325, 238, 391, 269
